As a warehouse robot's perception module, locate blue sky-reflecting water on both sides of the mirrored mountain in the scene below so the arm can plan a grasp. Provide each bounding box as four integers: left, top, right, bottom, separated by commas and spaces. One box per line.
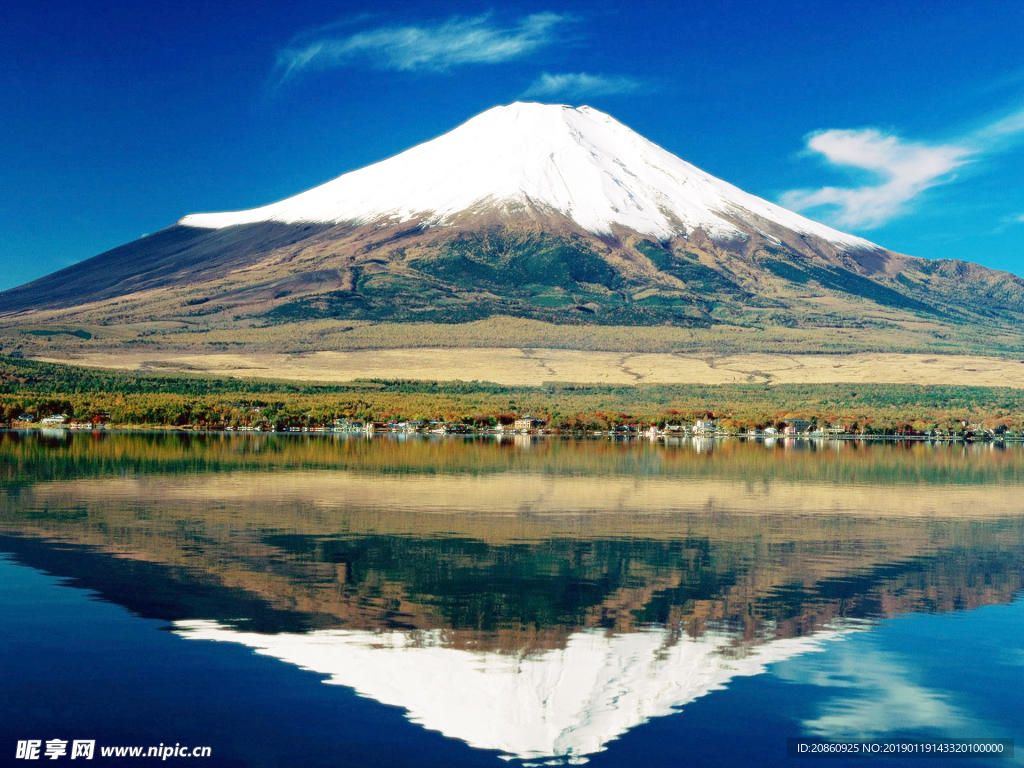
0, 559, 1024, 766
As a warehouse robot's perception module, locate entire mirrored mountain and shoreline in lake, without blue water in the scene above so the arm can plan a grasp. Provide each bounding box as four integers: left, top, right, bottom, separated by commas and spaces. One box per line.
0, 433, 1024, 761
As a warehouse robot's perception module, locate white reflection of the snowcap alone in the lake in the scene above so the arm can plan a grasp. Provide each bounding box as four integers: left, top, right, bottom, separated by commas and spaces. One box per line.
175, 622, 842, 763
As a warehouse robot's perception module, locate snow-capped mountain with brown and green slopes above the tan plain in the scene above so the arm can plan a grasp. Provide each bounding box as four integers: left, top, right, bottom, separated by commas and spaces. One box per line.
0, 103, 1024, 360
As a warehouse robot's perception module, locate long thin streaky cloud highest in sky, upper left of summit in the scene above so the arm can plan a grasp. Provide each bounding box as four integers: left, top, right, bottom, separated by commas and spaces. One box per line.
276, 13, 571, 82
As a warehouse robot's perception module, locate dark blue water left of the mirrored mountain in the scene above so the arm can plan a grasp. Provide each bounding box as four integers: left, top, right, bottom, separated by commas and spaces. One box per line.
0, 559, 497, 766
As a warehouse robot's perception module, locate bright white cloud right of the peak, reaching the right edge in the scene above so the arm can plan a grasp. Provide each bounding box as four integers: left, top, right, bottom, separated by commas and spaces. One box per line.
779, 110, 1024, 229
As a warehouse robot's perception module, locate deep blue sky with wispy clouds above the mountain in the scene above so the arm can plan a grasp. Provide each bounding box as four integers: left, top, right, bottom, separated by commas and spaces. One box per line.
0, 0, 1024, 289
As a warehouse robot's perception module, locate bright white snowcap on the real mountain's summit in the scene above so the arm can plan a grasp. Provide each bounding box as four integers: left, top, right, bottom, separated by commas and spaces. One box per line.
179, 102, 878, 249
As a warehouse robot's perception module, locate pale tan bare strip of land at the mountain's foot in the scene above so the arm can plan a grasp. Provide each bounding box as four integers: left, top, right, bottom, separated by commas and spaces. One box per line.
32, 348, 1024, 389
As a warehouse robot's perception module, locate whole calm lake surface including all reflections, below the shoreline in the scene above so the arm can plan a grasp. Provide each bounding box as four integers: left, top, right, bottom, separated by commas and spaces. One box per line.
0, 431, 1024, 768
